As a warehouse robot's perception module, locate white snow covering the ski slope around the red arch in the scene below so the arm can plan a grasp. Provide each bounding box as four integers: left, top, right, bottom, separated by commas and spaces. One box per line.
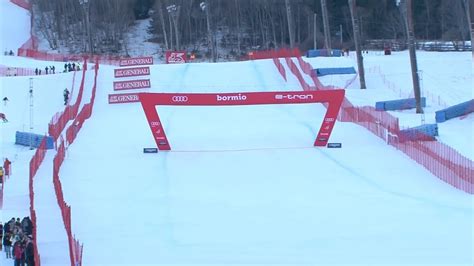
0, 1, 474, 265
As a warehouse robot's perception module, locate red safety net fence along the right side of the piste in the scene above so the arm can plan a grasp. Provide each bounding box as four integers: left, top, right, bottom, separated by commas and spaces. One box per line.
270, 47, 474, 194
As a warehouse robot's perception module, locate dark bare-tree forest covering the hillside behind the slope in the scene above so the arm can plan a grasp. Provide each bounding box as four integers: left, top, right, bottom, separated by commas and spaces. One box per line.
31, 0, 470, 55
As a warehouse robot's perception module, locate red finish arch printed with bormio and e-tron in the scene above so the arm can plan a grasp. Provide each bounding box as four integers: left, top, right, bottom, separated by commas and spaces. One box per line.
138, 90, 345, 151
